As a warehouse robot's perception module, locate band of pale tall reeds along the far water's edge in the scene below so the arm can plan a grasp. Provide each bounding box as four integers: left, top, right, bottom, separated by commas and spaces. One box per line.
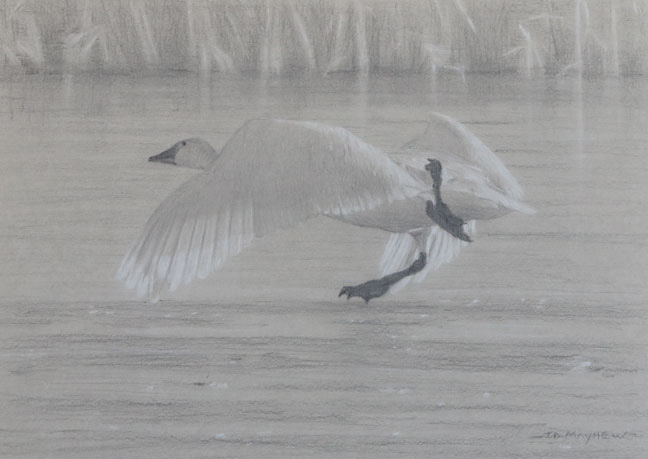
0, 0, 648, 76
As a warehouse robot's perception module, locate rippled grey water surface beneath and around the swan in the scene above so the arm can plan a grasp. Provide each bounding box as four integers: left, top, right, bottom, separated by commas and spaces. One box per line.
0, 74, 648, 459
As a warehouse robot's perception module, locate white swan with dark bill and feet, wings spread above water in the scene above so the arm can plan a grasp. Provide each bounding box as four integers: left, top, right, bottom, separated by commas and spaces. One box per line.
118, 114, 533, 302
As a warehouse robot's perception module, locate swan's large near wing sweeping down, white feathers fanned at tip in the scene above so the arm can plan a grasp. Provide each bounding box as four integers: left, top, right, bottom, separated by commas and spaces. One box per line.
118, 120, 425, 301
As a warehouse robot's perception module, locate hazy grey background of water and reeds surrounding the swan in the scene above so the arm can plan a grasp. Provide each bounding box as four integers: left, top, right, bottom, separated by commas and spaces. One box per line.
0, 0, 648, 459
